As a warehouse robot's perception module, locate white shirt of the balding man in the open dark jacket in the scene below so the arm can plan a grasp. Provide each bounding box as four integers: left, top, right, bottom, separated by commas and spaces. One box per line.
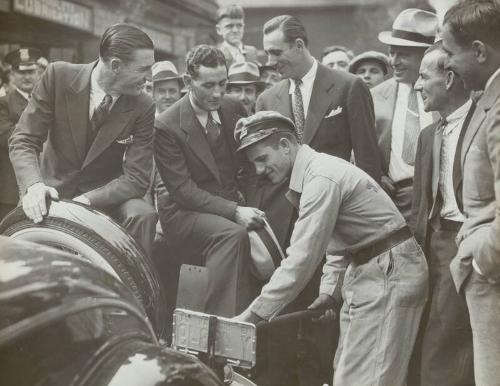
438, 100, 472, 222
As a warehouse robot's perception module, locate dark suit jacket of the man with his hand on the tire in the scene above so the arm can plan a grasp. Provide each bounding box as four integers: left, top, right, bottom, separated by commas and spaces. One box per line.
9, 62, 154, 208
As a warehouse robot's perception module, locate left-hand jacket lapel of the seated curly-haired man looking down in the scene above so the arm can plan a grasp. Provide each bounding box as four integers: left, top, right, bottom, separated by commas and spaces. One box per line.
180, 94, 220, 183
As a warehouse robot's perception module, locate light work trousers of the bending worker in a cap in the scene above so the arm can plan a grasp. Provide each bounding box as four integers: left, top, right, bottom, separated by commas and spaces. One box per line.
333, 237, 428, 386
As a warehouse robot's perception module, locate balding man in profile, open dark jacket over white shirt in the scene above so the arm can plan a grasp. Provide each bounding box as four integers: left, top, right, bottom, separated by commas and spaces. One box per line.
411, 42, 474, 386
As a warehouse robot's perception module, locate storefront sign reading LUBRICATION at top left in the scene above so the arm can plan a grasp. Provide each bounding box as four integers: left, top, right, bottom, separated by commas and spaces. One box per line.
13, 0, 93, 32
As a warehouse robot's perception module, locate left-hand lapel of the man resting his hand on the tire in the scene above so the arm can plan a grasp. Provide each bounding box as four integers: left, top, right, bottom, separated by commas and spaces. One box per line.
65, 62, 96, 165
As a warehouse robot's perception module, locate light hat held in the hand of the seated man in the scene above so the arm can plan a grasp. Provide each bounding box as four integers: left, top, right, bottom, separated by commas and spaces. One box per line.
248, 220, 285, 281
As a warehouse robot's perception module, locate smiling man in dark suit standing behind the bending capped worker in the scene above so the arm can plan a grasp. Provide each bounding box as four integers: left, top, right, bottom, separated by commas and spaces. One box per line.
256, 15, 382, 246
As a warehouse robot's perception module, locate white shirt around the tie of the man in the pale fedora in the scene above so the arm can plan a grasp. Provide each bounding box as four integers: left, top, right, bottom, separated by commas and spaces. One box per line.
389, 83, 433, 182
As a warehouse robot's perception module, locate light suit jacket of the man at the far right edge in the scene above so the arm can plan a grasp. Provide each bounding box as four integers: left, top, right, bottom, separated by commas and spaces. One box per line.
450, 75, 500, 288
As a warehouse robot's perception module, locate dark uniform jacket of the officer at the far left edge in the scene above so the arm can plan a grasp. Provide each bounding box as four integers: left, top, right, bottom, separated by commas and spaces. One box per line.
0, 90, 28, 205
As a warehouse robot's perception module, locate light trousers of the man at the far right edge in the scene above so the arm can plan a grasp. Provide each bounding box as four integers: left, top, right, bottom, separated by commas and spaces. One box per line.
464, 269, 500, 386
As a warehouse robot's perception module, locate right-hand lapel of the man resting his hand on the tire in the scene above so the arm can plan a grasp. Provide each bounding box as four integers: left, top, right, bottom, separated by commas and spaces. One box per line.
82, 95, 134, 168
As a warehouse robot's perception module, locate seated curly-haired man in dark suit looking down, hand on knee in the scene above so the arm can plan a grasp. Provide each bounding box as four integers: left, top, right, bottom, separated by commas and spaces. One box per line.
154, 45, 264, 316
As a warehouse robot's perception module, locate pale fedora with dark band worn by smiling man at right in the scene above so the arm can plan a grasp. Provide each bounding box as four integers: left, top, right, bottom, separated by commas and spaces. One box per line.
378, 8, 438, 47
